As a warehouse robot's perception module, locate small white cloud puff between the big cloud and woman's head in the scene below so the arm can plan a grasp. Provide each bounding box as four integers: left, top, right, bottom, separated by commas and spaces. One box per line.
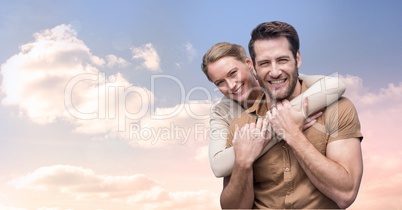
131, 43, 161, 72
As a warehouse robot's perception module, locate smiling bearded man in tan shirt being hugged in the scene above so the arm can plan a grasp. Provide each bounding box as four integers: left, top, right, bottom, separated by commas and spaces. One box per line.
221, 21, 363, 209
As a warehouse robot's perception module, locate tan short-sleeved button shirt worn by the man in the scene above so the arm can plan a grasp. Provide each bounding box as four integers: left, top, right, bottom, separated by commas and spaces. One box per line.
227, 80, 363, 209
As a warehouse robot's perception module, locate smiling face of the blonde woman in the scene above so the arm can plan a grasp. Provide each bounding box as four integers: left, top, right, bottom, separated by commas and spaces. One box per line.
208, 56, 259, 103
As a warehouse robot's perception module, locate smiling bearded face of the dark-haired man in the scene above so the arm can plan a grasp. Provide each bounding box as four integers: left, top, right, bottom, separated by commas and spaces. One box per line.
254, 37, 301, 100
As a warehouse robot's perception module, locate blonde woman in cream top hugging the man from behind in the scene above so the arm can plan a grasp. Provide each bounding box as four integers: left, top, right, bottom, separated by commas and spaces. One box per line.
201, 42, 345, 177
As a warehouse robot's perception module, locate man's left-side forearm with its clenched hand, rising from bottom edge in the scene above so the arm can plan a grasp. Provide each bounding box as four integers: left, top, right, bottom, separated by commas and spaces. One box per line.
220, 118, 270, 209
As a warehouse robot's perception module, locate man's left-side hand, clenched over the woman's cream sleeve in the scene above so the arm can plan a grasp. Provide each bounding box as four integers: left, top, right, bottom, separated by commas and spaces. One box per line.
233, 118, 271, 165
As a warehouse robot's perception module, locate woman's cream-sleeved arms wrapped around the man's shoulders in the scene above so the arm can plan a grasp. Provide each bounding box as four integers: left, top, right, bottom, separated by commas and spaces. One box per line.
209, 75, 346, 178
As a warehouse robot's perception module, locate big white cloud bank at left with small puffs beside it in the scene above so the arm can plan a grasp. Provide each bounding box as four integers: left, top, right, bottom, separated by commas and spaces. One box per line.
1, 25, 214, 147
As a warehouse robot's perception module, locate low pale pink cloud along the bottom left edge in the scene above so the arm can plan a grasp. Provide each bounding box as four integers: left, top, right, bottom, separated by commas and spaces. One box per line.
5, 165, 218, 209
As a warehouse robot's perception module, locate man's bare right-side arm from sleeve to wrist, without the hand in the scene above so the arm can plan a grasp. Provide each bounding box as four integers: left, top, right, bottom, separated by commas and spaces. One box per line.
288, 136, 363, 208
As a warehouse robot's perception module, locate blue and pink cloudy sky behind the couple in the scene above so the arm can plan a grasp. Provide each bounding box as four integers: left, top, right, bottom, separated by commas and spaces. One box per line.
0, 0, 402, 210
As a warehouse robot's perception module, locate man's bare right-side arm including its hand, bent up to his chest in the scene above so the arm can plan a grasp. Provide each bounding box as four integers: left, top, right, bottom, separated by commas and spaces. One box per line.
268, 101, 363, 208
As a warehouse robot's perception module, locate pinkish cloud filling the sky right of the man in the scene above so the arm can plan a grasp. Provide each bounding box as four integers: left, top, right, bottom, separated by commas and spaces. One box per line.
343, 75, 402, 209
